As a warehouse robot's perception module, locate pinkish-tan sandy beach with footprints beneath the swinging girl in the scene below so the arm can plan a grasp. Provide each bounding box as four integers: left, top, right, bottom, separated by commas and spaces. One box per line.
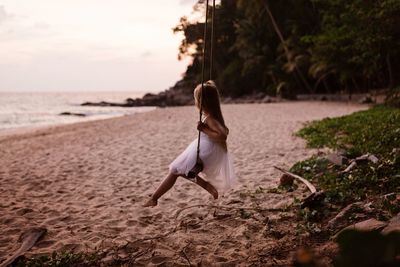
0, 102, 367, 266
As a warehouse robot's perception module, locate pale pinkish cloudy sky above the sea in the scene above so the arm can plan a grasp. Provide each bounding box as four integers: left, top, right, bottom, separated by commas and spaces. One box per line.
0, 0, 196, 92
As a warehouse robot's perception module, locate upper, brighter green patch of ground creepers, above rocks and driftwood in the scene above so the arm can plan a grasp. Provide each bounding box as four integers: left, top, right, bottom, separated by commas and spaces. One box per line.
297, 106, 400, 156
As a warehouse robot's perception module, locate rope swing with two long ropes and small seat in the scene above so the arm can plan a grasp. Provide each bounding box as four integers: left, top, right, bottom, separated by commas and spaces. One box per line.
187, 0, 215, 179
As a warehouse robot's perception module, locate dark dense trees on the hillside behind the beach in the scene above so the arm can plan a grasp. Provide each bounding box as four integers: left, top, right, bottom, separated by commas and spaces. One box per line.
174, 0, 400, 97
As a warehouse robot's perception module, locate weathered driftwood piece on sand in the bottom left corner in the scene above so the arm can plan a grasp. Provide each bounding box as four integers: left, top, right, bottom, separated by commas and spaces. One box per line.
0, 228, 47, 267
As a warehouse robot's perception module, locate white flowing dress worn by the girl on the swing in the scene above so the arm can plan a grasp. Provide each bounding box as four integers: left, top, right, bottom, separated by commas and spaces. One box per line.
169, 117, 236, 193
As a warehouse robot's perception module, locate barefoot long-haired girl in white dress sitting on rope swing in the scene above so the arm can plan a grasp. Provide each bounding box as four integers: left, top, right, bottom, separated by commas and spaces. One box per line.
144, 81, 235, 207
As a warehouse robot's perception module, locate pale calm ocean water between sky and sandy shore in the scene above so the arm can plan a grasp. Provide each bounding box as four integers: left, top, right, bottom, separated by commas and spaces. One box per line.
0, 92, 155, 131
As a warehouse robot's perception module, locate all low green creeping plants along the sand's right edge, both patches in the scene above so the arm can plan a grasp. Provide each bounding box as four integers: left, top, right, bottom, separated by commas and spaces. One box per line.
291, 106, 400, 207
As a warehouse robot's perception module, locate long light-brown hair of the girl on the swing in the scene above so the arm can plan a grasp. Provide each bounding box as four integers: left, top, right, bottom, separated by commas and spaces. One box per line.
194, 80, 228, 132
